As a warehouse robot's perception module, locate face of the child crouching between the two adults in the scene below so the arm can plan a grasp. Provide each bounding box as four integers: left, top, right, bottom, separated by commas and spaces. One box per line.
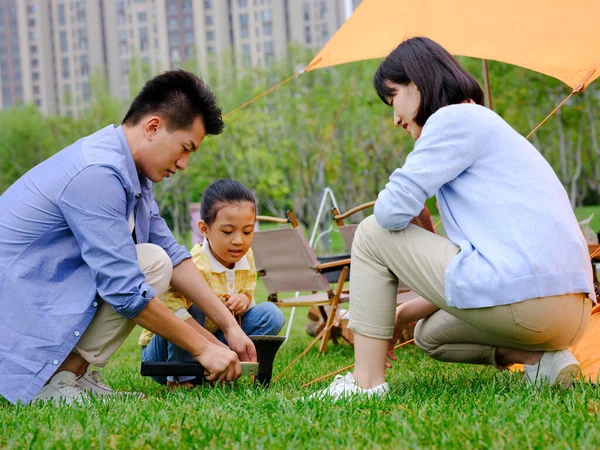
198, 202, 256, 269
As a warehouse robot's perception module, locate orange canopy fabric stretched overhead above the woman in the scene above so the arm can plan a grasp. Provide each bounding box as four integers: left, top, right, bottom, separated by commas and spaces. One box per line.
305, 0, 600, 89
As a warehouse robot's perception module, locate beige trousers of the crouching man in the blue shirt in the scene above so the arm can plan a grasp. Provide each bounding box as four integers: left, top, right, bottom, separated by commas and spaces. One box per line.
73, 244, 173, 367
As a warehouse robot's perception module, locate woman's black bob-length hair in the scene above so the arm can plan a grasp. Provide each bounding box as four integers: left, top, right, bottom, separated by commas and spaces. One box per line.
373, 37, 483, 126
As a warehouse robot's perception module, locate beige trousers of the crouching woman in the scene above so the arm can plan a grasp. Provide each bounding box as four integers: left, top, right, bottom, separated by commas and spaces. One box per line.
348, 216, 592, 365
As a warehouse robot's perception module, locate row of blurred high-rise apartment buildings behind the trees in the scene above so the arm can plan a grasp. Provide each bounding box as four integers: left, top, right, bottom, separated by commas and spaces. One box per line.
0, 0, 360, 116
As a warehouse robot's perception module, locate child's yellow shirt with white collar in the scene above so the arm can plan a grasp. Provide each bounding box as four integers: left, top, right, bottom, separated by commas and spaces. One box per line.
138, 240, 256, 347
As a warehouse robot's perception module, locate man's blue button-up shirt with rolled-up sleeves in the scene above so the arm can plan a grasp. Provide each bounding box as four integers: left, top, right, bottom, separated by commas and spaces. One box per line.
0, 125, 190, 403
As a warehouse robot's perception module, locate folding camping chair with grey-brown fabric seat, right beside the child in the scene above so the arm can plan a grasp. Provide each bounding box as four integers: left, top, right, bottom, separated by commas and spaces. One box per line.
252, 211, 350, 352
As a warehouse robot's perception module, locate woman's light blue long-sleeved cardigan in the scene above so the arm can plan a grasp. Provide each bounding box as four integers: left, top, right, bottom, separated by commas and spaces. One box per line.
375, 104, 595, 308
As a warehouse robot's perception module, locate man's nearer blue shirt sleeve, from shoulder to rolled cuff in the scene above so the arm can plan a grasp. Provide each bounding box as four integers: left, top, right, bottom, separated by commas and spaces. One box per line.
58, 166, 155, 319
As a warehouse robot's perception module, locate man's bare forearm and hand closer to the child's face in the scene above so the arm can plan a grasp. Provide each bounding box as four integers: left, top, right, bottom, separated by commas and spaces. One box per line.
171, 259, 256, 361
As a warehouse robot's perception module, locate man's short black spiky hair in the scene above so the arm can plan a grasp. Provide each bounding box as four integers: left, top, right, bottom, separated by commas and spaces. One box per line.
122, 69, 224, 134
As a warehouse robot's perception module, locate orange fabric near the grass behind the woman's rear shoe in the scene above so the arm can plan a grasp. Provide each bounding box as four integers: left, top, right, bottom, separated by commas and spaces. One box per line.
510, 305, 600, 383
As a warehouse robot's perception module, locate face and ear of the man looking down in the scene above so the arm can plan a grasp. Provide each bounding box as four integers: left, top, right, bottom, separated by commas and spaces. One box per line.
136, 116, 206, 183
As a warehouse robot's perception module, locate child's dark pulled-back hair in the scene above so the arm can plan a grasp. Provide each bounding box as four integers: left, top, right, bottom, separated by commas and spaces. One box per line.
200, 178, 256, 226
